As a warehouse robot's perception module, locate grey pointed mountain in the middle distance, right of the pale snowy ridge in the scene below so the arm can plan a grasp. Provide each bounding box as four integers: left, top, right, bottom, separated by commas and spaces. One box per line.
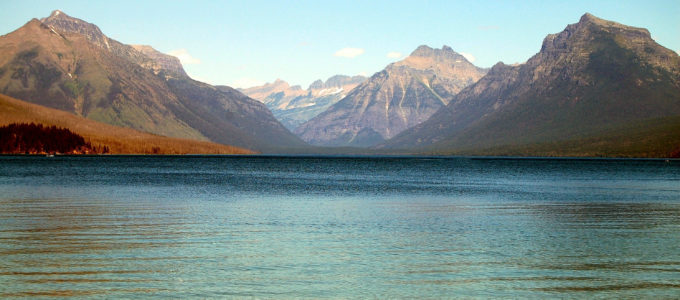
295, 46, 486, 147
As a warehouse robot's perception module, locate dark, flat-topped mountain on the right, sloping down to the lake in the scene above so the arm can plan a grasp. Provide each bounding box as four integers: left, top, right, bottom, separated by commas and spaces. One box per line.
378, 14, 680, 156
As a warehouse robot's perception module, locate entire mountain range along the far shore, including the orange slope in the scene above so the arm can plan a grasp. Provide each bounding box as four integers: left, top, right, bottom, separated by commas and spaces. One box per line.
0, 10, 680, 157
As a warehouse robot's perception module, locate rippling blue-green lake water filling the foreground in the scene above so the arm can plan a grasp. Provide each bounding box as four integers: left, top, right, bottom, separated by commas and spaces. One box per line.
0, 156, 680, 298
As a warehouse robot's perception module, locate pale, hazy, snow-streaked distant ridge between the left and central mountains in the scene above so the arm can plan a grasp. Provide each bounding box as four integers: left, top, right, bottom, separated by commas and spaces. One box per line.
240, 75, 366, 130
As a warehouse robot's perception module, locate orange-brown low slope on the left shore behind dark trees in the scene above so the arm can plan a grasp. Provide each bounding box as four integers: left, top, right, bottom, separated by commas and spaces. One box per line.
0, 94, 253, 154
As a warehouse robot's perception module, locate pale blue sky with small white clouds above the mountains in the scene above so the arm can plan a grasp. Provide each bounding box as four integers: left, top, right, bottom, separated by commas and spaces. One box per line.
0, 0, 680, 88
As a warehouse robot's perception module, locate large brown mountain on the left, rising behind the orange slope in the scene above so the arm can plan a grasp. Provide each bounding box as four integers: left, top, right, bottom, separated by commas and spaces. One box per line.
0, 11, 304, 151
